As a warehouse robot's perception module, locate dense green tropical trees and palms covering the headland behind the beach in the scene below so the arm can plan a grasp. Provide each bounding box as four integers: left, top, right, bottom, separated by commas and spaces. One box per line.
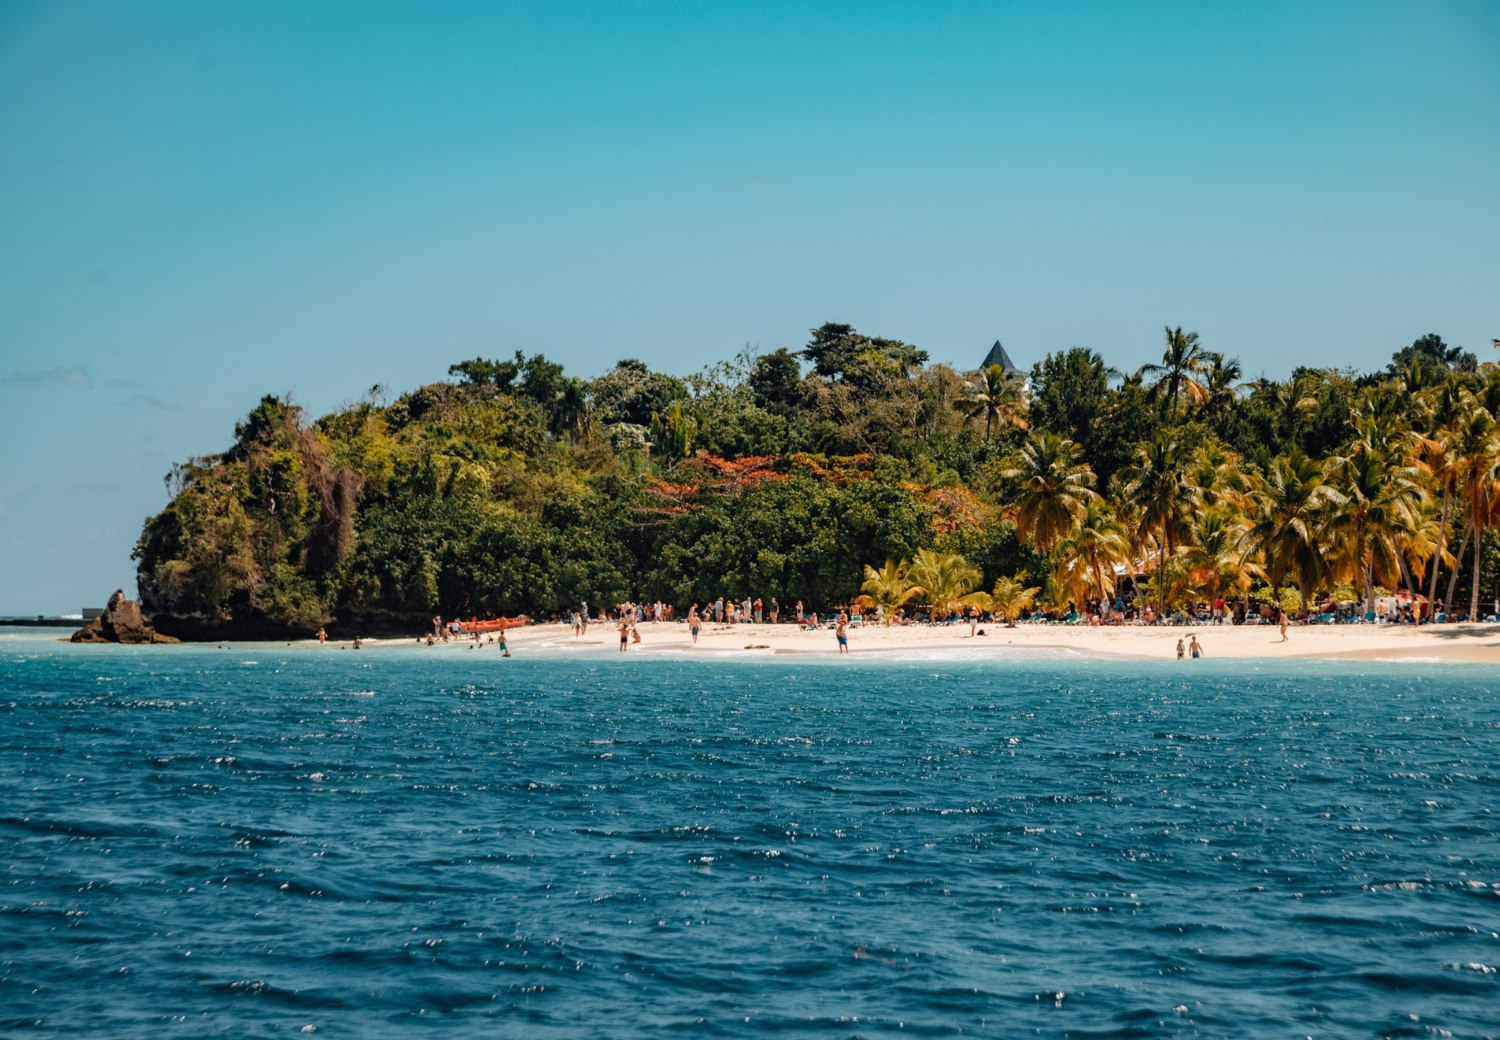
137, 324, 1500, 630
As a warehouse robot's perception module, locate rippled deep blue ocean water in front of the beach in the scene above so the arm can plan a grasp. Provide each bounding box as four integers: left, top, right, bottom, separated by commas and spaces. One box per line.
0, 632, 1500, 1038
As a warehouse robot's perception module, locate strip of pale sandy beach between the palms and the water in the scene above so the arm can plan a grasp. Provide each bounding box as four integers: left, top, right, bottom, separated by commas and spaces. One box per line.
438, 621, 1500, 663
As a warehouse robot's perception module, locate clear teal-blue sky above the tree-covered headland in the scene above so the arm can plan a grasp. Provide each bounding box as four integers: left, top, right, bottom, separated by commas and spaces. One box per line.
0, 0, 1500, 614
